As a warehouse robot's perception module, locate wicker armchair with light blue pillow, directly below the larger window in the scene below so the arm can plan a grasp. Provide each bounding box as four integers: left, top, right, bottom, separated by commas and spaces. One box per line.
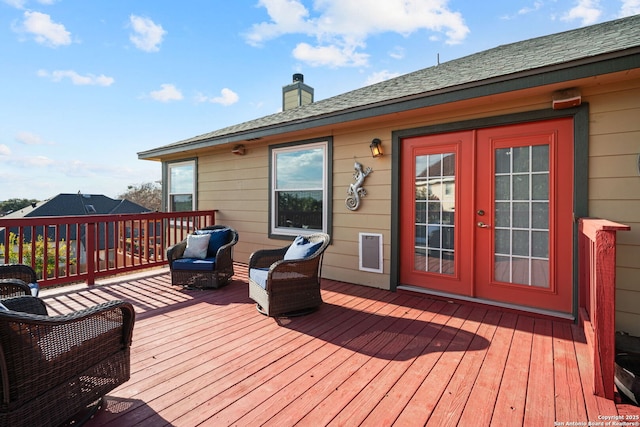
249, 233, 330, 317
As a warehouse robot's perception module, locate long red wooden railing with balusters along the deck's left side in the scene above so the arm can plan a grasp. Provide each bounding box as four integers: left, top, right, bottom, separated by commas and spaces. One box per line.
0, 210, 216, 287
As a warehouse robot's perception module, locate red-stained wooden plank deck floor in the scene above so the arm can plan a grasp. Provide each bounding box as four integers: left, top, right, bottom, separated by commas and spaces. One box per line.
43, 265, 640, 427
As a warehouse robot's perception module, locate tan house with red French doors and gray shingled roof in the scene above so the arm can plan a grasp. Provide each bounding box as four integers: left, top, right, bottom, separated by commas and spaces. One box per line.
138, 15, 640, 335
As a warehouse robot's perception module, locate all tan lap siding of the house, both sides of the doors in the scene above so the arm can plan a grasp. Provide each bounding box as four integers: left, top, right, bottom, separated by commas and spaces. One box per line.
198, 79, 640, 320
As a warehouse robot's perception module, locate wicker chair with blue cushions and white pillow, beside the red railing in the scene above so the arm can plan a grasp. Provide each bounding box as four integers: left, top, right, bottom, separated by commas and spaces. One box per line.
167, 225, 238, 288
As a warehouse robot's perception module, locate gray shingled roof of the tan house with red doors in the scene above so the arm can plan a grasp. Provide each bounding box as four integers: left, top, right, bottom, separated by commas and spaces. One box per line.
138, 15, 640, 159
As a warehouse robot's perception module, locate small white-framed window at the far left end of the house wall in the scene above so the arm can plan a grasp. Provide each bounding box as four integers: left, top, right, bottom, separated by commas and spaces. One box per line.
167, 160, 196, 212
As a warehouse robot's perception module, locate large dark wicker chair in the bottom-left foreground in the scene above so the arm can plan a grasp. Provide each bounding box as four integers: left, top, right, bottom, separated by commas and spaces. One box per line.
0, 296, 135, 426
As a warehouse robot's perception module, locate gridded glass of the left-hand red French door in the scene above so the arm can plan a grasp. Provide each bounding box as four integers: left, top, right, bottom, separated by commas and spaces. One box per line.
414, 153, 456, 275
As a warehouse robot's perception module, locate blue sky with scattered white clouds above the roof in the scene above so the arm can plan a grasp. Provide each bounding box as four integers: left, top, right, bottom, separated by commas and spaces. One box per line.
0, 0, 640, 200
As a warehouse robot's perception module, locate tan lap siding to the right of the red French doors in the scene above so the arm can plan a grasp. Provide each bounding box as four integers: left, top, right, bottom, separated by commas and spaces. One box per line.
583, 79, 640, 335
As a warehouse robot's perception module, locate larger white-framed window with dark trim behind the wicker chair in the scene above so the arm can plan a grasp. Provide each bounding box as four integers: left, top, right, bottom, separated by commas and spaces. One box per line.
270, 140, 331, 236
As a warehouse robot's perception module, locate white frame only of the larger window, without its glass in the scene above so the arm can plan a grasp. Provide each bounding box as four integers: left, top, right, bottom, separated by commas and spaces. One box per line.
269, 139, 331, 236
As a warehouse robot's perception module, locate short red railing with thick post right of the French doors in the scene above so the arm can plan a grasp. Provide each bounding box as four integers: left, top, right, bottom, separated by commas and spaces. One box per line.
578, 218, 630, 399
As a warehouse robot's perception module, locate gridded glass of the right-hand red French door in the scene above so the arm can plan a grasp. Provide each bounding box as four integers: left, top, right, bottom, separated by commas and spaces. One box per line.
493, 145, 549, 288
